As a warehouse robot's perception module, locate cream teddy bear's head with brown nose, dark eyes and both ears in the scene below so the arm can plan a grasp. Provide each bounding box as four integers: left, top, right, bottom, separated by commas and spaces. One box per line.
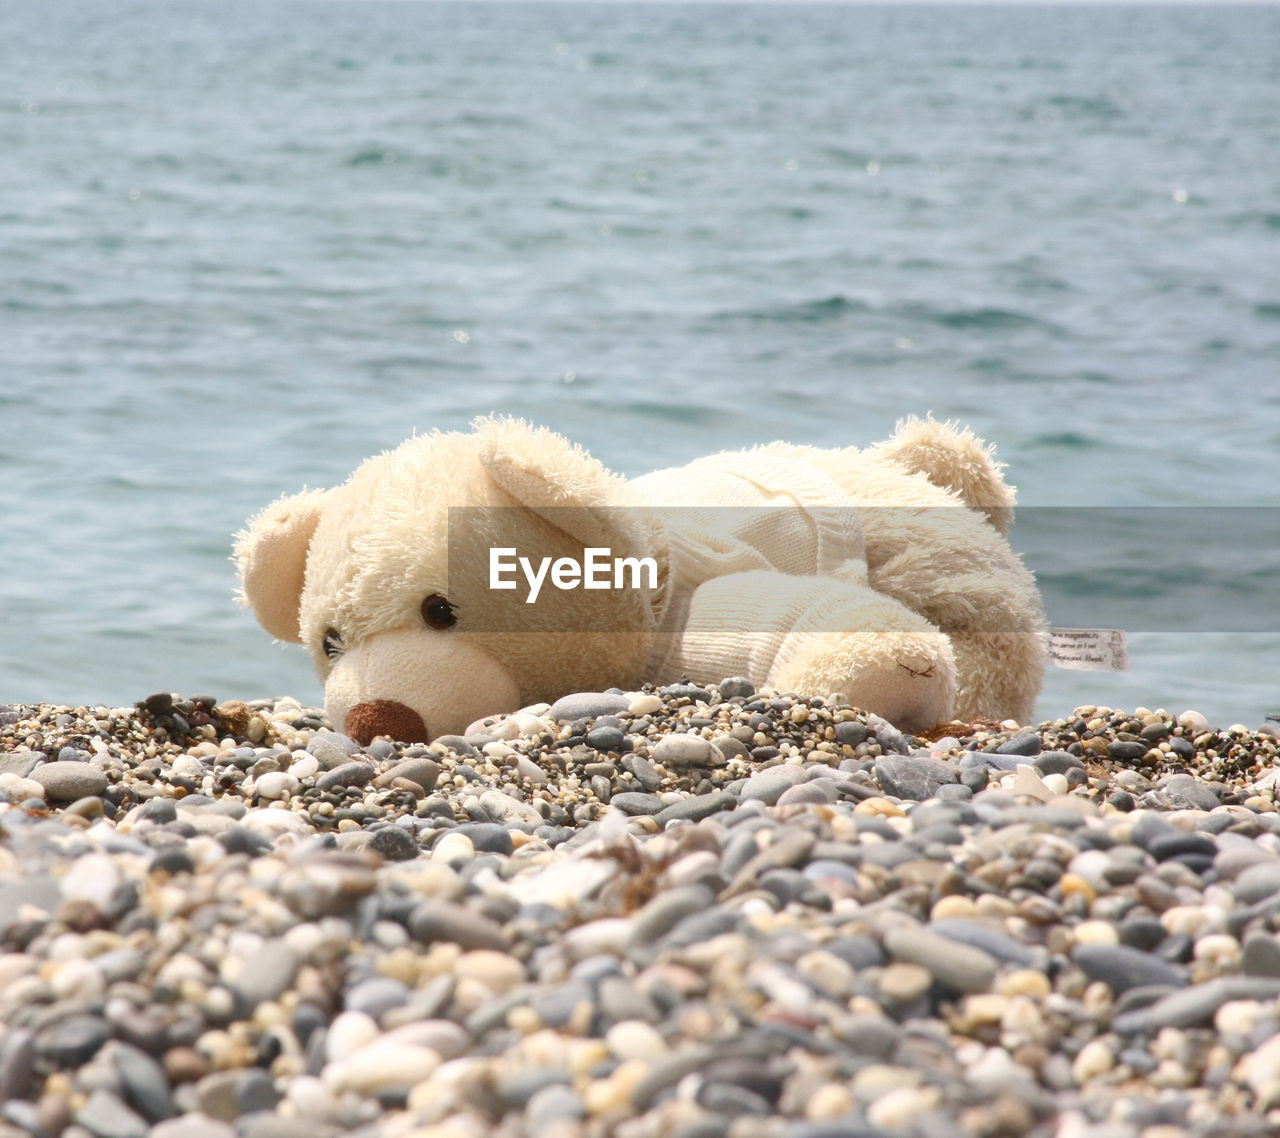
236, 419, 653, 742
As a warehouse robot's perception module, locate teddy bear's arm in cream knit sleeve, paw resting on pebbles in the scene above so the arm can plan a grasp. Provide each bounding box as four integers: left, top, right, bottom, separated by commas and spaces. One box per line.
660, 571, 956, 730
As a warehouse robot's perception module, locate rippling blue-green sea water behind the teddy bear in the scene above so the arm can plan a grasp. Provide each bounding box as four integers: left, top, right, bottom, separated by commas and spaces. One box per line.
0, 0, 1280, 726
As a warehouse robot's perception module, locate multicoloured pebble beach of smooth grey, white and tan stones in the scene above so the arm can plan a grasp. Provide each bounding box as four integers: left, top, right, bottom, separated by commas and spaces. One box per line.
0, 678, 1280, 1138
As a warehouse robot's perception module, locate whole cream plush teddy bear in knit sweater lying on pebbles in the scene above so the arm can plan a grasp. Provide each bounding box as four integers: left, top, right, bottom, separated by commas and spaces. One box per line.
236, 417, 1046, 744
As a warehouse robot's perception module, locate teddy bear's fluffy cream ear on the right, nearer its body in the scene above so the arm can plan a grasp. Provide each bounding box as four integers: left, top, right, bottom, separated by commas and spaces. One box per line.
472, 417, 634, 547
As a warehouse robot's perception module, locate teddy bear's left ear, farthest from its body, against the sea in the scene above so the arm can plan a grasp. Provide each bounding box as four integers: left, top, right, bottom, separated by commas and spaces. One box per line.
236, 490, 326, 643
